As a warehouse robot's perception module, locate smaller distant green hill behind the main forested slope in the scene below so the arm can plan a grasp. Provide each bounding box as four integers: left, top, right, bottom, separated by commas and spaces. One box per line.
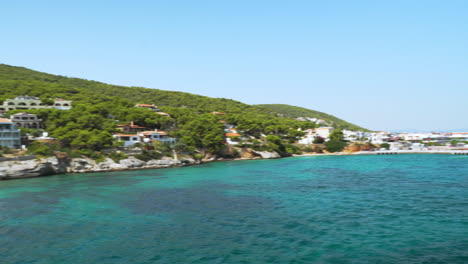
257, 104, 368, 131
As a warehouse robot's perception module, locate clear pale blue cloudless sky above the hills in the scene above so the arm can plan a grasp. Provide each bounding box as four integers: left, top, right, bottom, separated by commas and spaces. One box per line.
0, 0, 468, 131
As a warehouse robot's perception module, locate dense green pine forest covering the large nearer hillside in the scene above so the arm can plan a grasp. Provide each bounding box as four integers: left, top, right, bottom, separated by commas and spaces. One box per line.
0, 64, 359, 159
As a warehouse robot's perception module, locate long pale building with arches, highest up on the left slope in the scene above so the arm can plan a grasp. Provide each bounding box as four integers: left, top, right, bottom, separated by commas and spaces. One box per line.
0, 95, 72, 111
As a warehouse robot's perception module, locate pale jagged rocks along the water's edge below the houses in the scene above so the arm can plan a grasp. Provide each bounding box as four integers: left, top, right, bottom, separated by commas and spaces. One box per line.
0, 151, 280, 180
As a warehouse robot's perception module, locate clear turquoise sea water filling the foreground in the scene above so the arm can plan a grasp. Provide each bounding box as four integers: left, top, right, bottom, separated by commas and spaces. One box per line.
0, 155, 468, 264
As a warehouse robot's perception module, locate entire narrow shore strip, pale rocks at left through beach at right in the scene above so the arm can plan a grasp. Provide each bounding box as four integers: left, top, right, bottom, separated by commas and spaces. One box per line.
0, 150, 468, 180
